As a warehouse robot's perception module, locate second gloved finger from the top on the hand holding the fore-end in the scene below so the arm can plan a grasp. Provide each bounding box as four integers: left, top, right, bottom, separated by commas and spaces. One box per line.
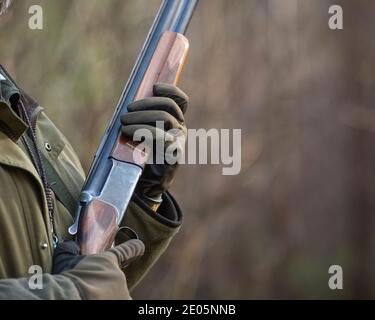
128, 97, 185, 123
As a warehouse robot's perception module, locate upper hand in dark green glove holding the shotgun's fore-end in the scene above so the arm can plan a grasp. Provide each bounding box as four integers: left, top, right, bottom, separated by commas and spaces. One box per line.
121, 83, 188, 206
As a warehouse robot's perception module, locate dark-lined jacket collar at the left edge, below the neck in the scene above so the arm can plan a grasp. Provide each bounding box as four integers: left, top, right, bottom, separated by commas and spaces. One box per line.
0, 65, 41, 141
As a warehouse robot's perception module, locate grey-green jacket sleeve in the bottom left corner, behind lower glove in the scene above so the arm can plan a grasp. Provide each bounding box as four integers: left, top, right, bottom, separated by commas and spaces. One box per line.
0, 274, 81, 300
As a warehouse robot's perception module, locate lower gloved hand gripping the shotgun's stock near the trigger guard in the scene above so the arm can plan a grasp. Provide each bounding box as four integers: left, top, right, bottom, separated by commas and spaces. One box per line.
52, 239, 145, 300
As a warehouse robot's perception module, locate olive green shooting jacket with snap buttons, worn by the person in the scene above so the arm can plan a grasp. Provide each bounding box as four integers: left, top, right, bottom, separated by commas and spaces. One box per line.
0, 68, 182, 299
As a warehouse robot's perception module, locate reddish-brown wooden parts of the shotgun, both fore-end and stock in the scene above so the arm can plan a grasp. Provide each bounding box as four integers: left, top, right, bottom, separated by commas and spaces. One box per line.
77, 31, 189, 255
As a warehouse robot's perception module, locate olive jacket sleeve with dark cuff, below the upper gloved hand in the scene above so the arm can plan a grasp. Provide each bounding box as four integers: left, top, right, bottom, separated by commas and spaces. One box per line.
116, 192, 182, 290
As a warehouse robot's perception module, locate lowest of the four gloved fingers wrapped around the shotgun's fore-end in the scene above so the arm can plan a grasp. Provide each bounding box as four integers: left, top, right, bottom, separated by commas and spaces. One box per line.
121, 124, 175, 146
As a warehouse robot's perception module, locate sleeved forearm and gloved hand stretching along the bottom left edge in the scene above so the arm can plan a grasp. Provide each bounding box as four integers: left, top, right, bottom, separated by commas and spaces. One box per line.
0, 240, 137, 300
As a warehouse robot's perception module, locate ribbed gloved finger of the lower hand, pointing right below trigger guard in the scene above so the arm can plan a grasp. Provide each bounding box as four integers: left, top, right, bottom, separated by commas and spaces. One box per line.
108, 239, 145, 267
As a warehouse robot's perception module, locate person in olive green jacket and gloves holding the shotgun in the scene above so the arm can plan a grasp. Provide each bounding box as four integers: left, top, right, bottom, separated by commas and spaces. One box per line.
0, 0, 188, 299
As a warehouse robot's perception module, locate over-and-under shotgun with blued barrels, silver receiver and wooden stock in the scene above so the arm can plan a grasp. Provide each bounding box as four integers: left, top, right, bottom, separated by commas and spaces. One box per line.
69, 0, 198, 255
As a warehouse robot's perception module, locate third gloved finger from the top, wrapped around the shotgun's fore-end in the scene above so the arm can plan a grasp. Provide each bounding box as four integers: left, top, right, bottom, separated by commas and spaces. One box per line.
121, 110, 183, 131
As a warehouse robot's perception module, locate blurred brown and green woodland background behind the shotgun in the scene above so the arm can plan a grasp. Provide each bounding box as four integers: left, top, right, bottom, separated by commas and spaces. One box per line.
0, 0, 375, 299
